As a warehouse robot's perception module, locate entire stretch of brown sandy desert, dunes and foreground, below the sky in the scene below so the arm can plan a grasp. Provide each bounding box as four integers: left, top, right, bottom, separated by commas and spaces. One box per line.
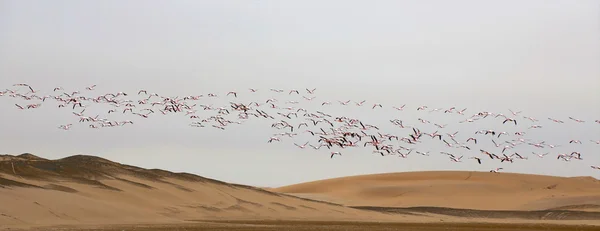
0, 154, 600, 230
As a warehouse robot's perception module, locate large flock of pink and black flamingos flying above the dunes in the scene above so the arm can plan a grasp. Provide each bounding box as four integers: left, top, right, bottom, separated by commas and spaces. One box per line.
0, 83, 600, 173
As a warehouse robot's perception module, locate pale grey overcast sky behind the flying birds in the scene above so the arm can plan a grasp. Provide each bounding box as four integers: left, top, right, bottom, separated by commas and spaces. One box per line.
0, 0, 600, 187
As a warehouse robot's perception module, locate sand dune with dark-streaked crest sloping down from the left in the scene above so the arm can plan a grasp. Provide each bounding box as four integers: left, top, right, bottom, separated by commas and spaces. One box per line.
0, 155, 404, 227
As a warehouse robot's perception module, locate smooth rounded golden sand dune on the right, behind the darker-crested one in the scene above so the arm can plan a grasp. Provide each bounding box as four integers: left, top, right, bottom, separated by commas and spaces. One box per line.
271, 171, 600, 211
